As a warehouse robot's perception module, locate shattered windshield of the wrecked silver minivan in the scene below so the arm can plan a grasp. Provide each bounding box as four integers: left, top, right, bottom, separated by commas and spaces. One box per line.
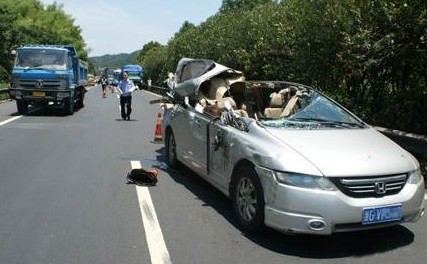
259, 90, 366, 129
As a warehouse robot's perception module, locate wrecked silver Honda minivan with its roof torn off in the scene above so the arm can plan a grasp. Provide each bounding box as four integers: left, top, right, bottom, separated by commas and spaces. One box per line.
158, 58, 425, 235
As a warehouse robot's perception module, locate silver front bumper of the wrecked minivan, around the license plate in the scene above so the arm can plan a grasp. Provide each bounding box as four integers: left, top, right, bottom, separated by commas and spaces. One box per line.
264, 168, 425, 235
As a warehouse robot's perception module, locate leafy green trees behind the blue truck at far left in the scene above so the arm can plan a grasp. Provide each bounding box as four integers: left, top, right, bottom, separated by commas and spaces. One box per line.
0, 0, 87, 81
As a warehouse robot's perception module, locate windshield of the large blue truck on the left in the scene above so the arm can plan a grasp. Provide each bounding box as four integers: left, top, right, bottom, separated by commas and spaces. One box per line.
15, 49, 67, 70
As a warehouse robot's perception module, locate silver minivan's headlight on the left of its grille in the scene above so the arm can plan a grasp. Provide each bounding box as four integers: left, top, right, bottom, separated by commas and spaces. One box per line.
274, 171, 336, 191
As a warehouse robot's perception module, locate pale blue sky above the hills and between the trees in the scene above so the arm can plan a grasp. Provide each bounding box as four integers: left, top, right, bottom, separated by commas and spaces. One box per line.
39, 0, 222, 57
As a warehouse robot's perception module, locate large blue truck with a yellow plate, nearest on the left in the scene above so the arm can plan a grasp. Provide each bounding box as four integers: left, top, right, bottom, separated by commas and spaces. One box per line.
10, 45, 88, 115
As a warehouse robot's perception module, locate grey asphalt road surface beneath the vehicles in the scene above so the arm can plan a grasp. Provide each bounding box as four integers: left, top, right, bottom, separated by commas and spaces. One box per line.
0, 86, 427, 264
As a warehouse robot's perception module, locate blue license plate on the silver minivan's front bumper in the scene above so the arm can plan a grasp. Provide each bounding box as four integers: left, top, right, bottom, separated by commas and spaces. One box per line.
362, 204, 403, 225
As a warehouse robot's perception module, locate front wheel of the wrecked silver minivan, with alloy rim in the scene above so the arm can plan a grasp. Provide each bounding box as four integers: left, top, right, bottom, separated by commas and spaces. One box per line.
231, 166, 265, 232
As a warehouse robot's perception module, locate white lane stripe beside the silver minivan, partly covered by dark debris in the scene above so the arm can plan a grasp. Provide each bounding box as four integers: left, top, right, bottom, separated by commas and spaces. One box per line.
131, 160, 172, 264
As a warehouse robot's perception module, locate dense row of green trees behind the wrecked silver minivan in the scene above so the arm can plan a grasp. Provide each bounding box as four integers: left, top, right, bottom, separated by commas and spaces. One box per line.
141, 0, 427, 134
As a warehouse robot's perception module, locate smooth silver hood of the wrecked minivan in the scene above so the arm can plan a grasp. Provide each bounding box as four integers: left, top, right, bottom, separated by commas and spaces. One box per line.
267, 128, 417, 177
